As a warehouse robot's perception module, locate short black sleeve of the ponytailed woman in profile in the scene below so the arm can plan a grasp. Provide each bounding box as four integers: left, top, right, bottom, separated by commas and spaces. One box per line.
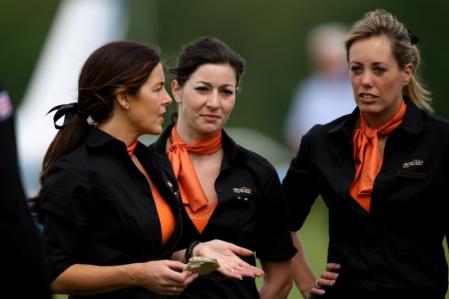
41, 161, 90, 281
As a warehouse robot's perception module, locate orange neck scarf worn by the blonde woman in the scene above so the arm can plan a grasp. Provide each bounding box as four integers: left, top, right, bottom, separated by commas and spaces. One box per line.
349, 101, 407, 212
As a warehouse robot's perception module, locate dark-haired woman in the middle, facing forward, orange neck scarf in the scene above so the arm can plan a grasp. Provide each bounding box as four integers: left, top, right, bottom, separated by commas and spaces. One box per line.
150, 37, 295, 299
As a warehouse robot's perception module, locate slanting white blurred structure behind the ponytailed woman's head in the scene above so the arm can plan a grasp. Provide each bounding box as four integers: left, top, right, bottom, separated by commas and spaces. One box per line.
17, 0, 127, 196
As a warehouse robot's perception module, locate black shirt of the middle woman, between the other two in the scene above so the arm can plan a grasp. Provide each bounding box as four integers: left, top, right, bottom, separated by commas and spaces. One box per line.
150, 126, 295, 298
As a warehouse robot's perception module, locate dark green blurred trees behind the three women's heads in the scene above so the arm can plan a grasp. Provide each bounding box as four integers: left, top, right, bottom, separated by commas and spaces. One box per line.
0, 0, 449, 146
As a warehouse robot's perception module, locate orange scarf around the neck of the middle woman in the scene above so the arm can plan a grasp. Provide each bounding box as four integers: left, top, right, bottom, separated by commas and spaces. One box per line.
168, 126, 222, 233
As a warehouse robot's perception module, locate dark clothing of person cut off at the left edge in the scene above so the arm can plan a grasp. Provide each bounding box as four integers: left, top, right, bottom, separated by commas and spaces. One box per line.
0, 109, 51, 299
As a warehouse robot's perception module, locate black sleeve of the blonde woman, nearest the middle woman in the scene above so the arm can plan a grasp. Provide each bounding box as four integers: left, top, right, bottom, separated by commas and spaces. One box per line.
282, 129, 320, 231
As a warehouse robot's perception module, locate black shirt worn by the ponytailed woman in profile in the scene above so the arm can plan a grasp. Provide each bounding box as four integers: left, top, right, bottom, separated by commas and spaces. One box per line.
41, 128, 182, 298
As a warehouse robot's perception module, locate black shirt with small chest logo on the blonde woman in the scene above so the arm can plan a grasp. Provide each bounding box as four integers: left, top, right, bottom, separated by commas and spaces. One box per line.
283, 102, 449, 298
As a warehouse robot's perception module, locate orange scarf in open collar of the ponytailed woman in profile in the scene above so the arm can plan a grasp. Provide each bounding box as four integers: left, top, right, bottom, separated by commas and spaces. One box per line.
127, 140, 176, 244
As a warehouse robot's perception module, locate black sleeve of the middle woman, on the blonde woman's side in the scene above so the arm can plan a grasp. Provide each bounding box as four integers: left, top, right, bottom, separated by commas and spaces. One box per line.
256, 167, 296, 261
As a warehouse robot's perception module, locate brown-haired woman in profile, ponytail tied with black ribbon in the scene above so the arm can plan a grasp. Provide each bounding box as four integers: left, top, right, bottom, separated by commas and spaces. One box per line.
39, 41, 260, 298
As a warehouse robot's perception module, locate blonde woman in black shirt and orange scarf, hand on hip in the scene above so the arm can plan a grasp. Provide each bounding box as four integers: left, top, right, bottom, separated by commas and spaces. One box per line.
283, 10, 449, 299
